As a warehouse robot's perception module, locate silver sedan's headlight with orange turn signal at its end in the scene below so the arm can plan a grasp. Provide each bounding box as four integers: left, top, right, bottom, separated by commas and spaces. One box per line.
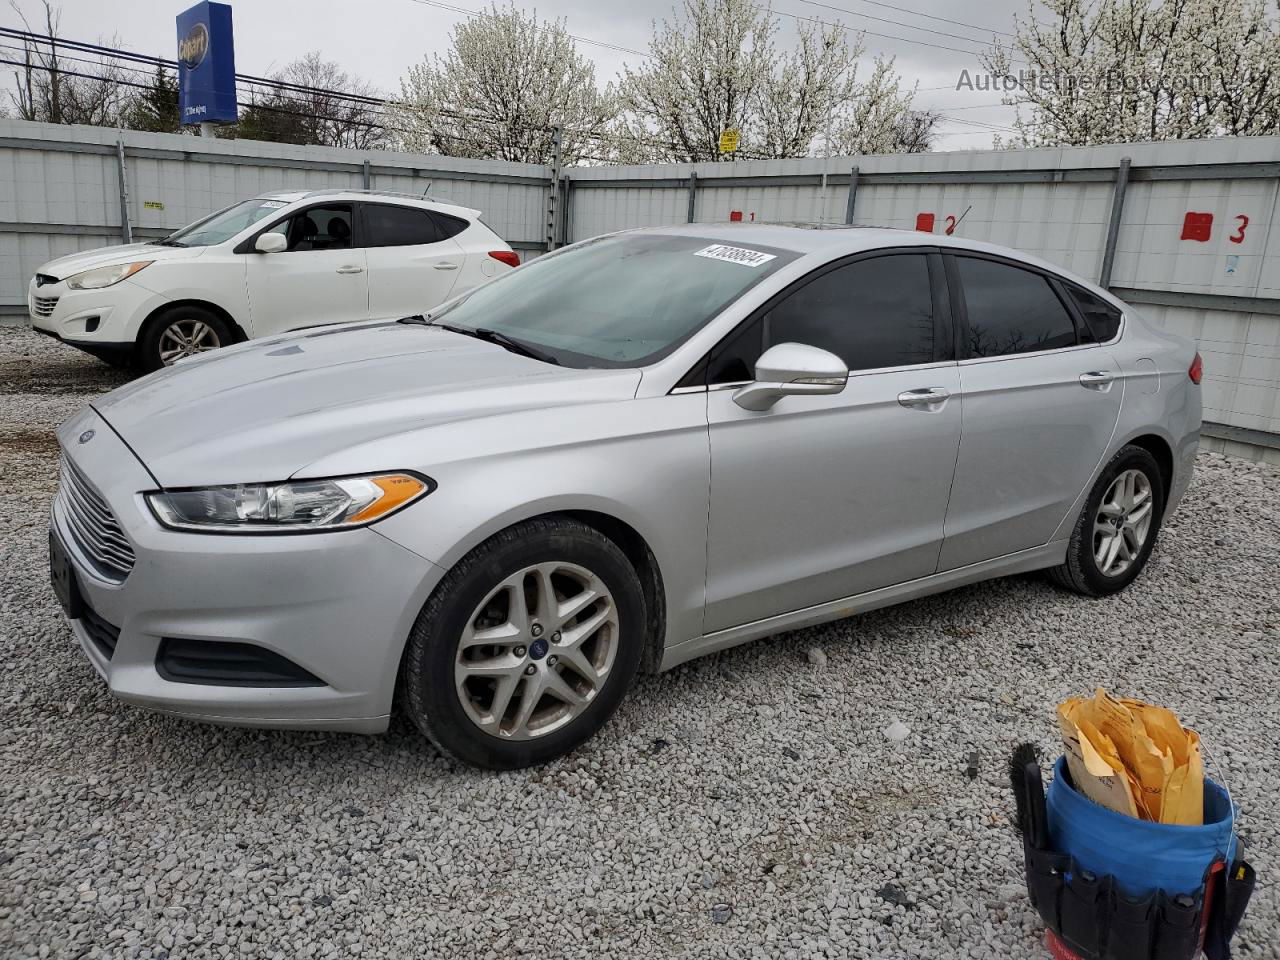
146, 474, 435, 534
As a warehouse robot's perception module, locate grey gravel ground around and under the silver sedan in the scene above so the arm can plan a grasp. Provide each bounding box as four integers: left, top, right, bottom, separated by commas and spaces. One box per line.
0, 328, 1280, 960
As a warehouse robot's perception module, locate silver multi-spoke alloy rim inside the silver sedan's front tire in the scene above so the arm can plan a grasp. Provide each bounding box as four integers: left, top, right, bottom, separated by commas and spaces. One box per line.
454, 562, 618, 740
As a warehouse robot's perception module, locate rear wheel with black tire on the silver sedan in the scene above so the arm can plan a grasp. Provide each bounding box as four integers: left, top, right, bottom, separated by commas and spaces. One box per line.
1050, 445, 1165, 596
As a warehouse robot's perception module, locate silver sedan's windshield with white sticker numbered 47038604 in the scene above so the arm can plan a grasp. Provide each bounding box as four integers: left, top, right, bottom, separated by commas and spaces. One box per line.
431, 233, 799, 367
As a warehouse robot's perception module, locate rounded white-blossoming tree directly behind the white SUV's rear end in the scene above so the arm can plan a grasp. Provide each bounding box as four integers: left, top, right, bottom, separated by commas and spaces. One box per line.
399, 5, 614, 164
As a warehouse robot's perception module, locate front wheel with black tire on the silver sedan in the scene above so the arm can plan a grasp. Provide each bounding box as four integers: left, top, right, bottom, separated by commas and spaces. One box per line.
401, 517, 646, 771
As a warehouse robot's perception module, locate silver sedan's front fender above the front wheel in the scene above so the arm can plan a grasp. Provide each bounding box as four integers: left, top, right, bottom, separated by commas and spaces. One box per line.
350, 394, 710, 645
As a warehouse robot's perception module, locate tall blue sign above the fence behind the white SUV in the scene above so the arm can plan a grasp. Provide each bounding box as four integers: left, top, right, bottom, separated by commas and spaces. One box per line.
178, 0, 239, 124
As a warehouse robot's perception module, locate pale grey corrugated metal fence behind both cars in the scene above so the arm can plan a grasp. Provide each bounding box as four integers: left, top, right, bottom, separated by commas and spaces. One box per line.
0, 120, 1280, 462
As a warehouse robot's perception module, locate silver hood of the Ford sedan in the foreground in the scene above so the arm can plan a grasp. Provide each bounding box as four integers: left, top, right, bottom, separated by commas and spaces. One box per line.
92, 321, 640, 486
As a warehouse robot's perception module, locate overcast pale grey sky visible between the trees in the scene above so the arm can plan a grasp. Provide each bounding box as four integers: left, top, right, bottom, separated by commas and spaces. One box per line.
0, 0, 1027, 150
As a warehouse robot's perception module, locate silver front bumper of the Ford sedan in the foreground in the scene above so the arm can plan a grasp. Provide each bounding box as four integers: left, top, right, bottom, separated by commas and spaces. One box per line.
51, 410, 443, 732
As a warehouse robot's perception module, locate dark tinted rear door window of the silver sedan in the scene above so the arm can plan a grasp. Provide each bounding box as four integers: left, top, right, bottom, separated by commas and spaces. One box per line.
956, 256, 1079, 357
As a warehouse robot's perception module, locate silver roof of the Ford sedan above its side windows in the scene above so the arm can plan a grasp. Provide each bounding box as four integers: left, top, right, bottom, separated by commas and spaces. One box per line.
624, 223, 1094, 289
